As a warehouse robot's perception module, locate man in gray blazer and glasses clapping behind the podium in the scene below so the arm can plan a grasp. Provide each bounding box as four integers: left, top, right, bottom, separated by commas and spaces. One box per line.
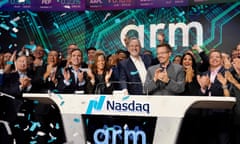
144, 43, 185, 95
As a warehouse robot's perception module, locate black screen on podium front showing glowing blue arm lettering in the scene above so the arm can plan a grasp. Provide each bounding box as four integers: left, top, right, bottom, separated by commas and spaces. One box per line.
83, 115, 157, 144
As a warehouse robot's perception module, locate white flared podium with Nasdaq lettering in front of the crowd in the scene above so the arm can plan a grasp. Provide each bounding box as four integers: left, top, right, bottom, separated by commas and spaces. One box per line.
23, 93, 236, 144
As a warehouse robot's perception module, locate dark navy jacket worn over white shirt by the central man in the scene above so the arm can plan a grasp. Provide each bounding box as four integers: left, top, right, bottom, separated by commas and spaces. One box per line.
119, 55, 151, 95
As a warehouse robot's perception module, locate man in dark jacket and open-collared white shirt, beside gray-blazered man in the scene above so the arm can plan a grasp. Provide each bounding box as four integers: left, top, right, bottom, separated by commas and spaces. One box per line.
119, 37, 151, 95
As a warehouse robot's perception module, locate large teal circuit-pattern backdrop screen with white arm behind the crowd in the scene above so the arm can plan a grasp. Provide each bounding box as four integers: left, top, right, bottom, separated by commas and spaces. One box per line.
0, 2, 240, 59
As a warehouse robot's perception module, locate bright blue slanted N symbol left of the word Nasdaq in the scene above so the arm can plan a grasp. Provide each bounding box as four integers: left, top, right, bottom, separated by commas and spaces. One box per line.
86, 96, 106, 114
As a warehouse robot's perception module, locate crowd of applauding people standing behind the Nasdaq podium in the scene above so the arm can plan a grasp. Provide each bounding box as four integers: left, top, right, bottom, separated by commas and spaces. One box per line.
0, 34, 240, 144
